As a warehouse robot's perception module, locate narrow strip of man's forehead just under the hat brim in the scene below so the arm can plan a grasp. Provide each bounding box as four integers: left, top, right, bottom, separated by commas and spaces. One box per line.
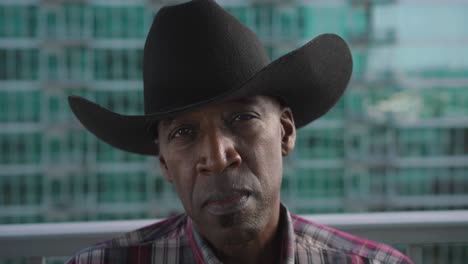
159, 95, 279, 127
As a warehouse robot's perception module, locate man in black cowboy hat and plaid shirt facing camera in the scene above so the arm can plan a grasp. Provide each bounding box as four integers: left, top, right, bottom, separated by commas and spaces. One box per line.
69, 0, 411, 263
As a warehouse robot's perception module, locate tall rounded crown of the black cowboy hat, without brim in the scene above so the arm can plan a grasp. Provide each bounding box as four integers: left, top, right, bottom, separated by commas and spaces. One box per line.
143, 0, 269, 114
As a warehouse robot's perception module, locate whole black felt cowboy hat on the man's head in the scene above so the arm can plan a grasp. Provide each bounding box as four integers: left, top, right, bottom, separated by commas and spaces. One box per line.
69, 0, 352, 155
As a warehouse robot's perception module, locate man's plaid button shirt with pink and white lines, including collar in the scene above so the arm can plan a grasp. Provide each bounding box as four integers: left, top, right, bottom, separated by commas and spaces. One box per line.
67, 206, 412, 264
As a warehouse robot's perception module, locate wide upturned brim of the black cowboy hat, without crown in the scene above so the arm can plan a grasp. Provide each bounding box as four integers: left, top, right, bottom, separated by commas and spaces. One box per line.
69, 34, 352, 155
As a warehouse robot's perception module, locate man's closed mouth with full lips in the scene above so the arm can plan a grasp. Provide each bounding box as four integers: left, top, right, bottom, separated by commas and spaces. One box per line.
204, 191, 250, 215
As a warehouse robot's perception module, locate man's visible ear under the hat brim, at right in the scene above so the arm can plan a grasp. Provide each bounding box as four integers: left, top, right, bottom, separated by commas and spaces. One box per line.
280, 107, 296, 156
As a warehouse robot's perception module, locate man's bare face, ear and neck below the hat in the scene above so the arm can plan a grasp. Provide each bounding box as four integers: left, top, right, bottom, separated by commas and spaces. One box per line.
158, 96, 296, 263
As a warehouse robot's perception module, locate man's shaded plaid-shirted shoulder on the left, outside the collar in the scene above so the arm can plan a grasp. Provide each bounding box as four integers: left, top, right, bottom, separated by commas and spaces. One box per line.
66, 214, 189, 264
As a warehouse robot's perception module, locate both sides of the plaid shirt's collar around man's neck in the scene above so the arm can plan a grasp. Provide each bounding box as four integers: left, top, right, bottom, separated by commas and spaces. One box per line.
187, 204, 295, 264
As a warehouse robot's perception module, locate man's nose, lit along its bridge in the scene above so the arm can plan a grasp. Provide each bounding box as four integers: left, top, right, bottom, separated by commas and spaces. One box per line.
197, 130, 242, 174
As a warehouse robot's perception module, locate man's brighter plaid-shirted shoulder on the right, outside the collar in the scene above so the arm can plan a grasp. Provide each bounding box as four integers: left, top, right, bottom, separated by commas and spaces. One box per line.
291, 214, 412, 264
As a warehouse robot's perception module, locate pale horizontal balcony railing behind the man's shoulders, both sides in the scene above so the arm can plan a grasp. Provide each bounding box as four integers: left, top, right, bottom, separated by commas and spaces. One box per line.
0, 210, 468, 263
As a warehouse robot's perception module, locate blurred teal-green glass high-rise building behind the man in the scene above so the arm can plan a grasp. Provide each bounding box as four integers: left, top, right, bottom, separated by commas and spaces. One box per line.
0, 0, 468, 263
